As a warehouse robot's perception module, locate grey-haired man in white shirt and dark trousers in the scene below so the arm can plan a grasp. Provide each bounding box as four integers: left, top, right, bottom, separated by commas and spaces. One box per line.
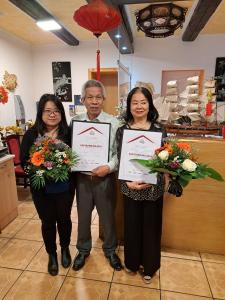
73, 80, 122, 271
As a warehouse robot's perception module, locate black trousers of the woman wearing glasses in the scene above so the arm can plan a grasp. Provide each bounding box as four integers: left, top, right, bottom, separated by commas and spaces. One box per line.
32, 192, 73, 254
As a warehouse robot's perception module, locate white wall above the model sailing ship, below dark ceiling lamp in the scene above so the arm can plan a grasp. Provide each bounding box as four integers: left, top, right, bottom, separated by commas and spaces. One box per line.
127, 35, 225, 93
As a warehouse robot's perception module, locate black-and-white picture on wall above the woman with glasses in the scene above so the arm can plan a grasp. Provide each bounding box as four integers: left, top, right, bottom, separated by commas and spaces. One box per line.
52, 61, 73, 102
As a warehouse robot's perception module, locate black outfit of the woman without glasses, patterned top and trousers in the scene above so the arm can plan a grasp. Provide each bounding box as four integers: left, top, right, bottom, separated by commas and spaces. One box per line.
116, 124, 166, 277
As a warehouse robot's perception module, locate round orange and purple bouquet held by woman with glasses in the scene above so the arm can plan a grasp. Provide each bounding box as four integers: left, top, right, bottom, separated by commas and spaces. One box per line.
26, 137, 78, 189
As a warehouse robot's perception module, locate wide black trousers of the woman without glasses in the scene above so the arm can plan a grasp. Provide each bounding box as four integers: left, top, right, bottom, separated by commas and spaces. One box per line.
123, 195, 163, 276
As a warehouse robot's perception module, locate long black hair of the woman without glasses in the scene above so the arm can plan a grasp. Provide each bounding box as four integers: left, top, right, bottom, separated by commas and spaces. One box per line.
125, 87, 159, 123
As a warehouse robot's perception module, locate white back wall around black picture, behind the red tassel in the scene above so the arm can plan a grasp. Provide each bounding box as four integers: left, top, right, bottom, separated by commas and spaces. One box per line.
33, 40, 118, 121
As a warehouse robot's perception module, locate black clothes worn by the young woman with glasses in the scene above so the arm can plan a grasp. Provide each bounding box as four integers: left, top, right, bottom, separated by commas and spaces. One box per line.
21, 128, 75, 254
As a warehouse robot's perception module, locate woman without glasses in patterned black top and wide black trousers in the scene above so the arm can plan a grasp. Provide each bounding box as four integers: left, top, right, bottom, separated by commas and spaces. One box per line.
117, 87, 166, 283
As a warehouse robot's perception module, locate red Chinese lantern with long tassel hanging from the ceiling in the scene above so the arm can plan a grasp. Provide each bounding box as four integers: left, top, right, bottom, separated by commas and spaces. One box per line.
73, 0, 121, 80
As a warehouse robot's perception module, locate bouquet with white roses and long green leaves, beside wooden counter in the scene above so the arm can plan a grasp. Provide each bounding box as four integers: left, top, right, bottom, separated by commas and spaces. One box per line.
135, 140, 224, 197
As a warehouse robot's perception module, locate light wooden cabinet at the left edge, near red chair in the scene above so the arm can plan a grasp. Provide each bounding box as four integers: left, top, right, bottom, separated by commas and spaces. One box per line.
0, 155, 18, 232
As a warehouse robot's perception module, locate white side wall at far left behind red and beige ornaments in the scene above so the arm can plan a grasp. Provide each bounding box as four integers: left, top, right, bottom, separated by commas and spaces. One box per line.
0, 31, 33, 125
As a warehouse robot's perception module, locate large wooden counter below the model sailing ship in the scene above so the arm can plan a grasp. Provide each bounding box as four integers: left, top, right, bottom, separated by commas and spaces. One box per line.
110, 138, 225, 254
